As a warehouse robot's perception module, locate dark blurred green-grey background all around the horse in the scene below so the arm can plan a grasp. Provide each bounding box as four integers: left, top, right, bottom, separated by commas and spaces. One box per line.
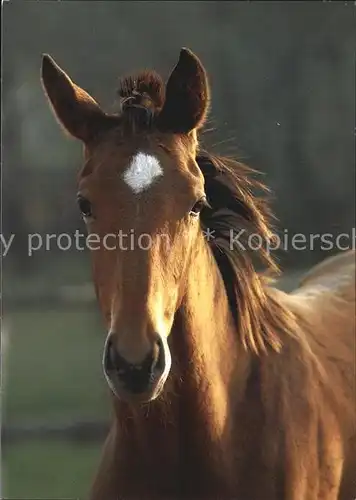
2, 0, 355, 498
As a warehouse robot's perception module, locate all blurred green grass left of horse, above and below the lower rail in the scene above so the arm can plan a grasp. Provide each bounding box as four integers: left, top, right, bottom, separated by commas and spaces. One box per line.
2, 305, 110, 500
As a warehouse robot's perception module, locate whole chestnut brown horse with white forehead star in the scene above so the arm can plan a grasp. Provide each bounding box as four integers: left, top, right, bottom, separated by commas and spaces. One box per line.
42, 49, 356, 500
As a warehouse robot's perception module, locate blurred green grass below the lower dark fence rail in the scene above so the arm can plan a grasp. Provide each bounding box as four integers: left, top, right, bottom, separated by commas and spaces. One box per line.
2, 441, 101, 500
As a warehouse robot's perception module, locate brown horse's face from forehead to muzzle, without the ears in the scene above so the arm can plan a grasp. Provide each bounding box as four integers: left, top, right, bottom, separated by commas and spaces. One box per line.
78, 130, 205, 399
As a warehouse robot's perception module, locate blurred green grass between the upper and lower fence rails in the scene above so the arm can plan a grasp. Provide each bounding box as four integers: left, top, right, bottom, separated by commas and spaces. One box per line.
2, 310, 109, 424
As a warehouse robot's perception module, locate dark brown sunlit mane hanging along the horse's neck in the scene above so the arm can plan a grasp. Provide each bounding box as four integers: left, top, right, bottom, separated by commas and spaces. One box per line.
197, 152, 293, 354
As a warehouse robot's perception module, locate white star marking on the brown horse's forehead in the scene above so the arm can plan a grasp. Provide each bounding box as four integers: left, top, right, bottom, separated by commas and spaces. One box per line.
124, 153, 163, 193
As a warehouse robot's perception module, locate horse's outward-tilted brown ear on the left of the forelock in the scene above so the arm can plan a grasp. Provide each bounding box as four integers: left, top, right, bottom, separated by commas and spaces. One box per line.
41, 54, 109, 143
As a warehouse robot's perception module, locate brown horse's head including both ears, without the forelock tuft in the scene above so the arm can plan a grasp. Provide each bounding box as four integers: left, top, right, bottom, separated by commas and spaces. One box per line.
42, 50, 208, 402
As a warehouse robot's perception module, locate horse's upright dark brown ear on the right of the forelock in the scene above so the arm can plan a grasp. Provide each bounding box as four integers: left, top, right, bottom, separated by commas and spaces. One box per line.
157, 48, 209, 133
